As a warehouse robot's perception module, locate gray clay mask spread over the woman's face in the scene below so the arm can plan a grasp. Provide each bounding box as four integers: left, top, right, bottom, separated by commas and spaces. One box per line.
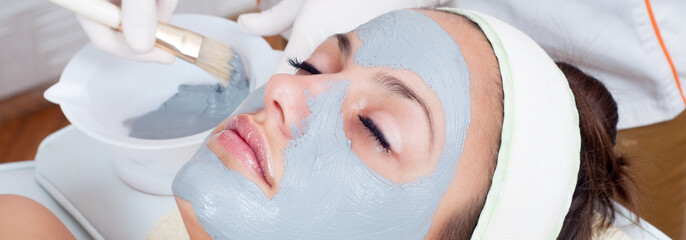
173, 10, 470, 239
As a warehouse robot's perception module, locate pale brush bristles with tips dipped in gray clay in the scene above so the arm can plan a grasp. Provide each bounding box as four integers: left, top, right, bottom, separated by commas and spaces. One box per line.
195, 37, 242, 86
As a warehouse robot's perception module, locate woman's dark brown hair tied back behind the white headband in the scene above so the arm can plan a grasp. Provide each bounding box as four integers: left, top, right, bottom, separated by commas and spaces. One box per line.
557, 62, 637, 239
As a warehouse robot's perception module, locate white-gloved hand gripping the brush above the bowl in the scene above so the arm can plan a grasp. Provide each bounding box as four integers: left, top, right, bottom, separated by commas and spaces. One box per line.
76, 0, 178, 64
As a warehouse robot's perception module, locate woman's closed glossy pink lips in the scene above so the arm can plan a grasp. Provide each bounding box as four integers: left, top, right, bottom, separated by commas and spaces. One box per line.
215, 115, 273, 188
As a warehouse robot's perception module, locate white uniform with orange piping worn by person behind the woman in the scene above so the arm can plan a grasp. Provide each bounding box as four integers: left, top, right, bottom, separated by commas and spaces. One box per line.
448, 0, 686, 129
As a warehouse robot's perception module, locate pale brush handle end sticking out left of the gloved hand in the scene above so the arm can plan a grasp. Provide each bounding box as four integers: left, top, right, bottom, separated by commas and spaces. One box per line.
49, 0, 121, 29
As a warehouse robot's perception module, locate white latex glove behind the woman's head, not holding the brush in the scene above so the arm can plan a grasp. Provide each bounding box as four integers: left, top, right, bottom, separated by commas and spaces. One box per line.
238, 0, 449, 73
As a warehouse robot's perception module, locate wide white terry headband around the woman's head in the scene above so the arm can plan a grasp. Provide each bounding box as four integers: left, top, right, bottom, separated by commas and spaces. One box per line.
438, 8, 581, 239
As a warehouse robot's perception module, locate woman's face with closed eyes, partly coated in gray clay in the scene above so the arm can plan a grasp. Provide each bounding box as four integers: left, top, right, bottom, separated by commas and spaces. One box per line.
174, 10, 498, 238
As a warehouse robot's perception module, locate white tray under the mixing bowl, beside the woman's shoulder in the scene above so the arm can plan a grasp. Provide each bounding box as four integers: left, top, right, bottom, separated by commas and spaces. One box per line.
35, 126, 176, 239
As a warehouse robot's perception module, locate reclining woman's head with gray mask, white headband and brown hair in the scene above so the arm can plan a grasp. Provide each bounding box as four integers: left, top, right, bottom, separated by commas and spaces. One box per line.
0, 7, 633, 239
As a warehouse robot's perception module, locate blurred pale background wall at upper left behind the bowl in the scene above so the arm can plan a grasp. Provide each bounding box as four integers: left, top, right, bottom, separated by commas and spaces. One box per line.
0, 0, 257, 101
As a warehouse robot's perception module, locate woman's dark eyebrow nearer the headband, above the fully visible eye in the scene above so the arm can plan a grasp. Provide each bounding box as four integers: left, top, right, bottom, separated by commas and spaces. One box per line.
374, 73, 434, 143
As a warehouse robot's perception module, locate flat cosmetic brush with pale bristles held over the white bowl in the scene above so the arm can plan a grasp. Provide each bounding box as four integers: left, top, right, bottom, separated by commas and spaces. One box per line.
49, 0, 243, 87
